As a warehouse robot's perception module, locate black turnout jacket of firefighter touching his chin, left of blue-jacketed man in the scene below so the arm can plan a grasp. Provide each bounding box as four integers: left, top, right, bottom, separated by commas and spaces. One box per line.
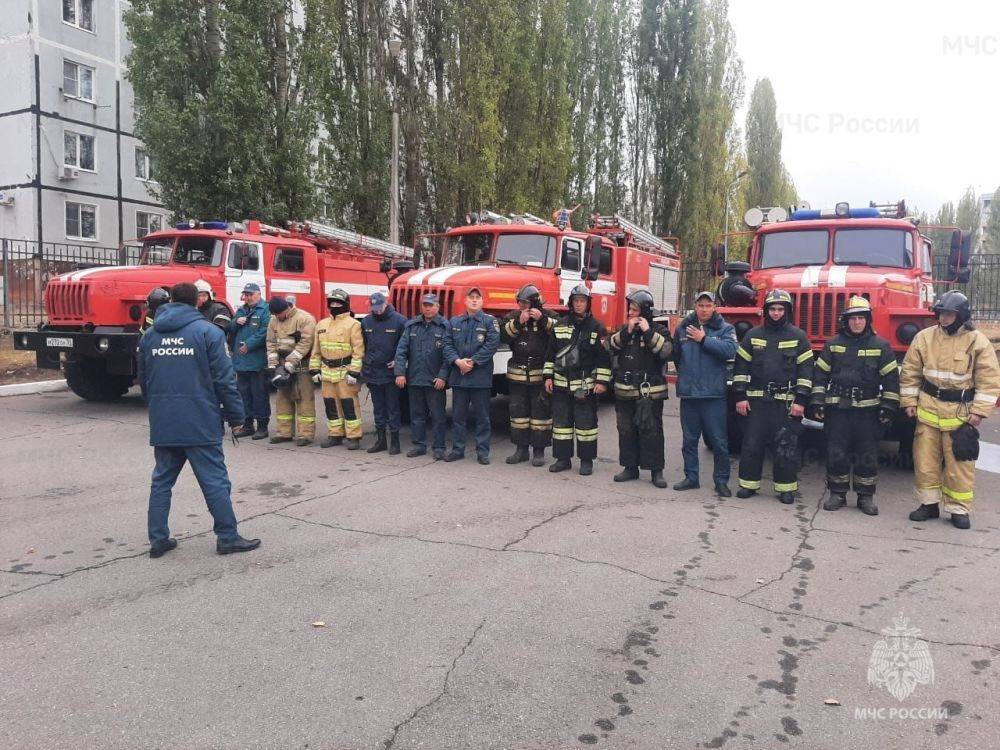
608, 323, 673, 400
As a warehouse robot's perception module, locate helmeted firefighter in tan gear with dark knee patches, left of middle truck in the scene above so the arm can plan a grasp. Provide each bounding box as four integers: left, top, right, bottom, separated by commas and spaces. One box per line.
309, 289, 365, 451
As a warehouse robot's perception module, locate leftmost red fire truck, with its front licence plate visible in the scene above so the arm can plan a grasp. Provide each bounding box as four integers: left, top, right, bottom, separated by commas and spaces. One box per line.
13, 221, 413, 401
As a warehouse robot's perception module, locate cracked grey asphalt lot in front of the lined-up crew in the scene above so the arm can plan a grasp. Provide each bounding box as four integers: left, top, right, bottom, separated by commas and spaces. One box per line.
0, 393, 1000, 750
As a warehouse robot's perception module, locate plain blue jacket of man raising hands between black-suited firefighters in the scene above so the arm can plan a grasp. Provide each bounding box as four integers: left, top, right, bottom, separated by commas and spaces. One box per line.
673, 313, 737, 398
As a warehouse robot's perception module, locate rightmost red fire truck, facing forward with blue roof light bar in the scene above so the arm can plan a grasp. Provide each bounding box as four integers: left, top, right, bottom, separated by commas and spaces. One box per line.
713, 201, 970, 454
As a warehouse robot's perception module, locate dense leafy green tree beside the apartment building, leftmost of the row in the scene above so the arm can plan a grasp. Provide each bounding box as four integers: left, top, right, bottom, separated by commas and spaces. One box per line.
124, 0, 336, 222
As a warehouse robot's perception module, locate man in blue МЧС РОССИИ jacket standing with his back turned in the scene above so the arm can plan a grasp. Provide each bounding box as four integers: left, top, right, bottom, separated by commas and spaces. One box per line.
139, 283, 260, 557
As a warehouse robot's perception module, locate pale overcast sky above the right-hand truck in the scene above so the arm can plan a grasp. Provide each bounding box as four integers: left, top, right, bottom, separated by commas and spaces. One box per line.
730, 0, 1000, 213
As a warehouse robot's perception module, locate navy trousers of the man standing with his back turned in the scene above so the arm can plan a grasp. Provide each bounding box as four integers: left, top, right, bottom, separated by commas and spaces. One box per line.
147, 444, 238, 545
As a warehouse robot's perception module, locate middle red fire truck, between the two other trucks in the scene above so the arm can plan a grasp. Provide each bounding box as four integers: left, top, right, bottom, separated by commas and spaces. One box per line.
390, 211, 681, 392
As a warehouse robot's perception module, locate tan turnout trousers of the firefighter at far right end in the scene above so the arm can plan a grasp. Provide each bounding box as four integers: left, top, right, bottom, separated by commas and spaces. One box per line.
913, 422, 976, 515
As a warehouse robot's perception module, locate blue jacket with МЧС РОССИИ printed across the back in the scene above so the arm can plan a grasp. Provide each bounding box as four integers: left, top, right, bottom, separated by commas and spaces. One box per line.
139, 302, 245, 447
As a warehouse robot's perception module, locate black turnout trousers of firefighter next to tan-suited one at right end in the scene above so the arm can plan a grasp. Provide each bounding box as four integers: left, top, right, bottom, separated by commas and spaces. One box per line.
823, 405, 880, 495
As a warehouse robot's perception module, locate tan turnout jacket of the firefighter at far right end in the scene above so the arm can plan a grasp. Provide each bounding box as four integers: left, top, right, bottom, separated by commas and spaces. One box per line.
900, 324, 1000, 431
